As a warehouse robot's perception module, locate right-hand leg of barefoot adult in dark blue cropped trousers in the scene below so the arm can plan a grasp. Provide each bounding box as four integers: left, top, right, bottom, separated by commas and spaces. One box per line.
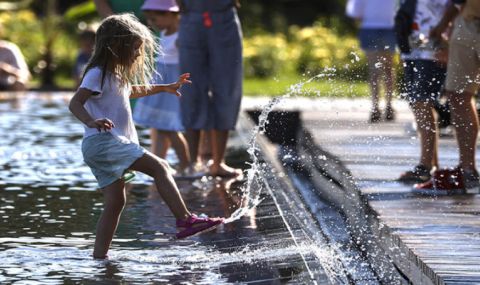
208, 11, 243, 177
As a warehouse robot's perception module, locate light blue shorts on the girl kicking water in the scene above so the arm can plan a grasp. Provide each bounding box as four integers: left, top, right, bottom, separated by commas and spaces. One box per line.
82, 132, 146, 188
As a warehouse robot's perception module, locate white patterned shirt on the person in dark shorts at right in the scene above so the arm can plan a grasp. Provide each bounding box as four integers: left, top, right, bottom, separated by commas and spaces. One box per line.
402, 0, 450, 60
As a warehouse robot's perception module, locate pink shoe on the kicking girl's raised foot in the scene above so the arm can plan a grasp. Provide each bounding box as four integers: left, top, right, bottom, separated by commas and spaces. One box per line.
175, 214, 224, 239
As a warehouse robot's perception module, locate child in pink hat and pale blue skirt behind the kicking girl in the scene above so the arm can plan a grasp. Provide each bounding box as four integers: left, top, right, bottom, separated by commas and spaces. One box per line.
133, 0, 191, 176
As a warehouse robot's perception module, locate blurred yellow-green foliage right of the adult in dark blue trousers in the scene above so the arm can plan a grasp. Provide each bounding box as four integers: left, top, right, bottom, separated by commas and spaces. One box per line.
244, 22, 367, 79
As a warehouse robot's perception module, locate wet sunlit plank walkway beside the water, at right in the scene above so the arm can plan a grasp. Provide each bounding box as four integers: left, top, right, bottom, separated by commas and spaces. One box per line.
274, 99, 480, 284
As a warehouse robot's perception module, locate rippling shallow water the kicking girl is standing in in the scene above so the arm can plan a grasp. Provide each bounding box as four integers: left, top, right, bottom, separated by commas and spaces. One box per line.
0, 93, 330, 284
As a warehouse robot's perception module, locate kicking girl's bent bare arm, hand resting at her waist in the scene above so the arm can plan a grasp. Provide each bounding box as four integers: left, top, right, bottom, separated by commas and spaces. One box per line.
68, 88, 115, 132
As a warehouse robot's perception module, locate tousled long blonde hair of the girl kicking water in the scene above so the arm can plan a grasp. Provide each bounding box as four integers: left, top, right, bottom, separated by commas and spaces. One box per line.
84, 13, 161, 87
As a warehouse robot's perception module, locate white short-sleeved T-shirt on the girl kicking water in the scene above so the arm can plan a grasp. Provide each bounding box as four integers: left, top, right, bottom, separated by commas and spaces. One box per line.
79, 67, 138, 144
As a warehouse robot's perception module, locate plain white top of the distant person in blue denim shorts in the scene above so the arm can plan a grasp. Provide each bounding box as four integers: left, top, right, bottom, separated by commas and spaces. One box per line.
346, 0, 397, 29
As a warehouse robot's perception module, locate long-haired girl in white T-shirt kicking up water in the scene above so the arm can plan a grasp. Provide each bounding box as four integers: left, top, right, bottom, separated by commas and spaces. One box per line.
69, 14, 223, 259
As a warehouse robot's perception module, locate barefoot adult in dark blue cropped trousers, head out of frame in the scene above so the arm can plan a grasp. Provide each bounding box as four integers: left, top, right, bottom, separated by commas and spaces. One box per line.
177, 0, 243, 177
